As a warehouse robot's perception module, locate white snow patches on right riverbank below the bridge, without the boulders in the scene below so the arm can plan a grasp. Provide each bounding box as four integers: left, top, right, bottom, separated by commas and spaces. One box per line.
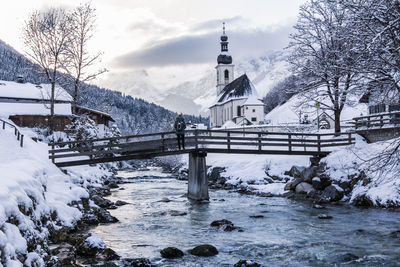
176, 135, 400, 207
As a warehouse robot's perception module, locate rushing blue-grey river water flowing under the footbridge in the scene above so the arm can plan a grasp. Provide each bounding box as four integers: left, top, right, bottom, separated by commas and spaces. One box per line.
92, 168, 400, 266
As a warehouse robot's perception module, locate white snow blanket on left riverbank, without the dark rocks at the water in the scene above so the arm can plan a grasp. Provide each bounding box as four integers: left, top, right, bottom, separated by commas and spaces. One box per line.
0, 120, 111, 266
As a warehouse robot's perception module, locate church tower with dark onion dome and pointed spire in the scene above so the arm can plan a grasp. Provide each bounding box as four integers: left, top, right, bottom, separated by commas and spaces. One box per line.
215, 22, 235, 95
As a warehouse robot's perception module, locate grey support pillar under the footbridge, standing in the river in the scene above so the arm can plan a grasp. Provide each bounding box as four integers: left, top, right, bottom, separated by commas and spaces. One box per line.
188, 151, 210, 200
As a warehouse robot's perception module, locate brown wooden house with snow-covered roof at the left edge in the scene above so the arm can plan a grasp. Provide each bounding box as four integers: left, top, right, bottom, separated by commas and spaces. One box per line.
0, 77, 114, 131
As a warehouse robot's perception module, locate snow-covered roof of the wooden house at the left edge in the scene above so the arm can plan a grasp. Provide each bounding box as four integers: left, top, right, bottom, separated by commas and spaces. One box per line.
0, 103, 72, 118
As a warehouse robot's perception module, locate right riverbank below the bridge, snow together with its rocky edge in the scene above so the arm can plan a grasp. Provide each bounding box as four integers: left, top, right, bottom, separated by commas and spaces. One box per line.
173, 136, 400, 207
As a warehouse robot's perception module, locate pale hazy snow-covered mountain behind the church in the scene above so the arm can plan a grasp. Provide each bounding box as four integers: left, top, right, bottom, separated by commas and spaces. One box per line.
97, 52, 289, 116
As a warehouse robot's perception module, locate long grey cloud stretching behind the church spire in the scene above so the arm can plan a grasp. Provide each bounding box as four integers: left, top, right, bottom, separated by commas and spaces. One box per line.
113, 22, 292, 68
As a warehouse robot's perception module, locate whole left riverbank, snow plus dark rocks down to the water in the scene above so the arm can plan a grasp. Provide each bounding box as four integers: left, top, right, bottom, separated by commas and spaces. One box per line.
0, 126, 126, 267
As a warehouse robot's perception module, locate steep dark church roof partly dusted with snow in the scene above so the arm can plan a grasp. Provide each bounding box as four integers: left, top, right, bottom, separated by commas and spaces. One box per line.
215, 74, 263, 105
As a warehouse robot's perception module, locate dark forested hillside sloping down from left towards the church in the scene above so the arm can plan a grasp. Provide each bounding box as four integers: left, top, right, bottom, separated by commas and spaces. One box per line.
0, 40, 207, 134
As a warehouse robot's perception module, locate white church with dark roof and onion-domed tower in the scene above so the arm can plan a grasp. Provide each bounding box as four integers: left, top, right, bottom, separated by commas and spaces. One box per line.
210, 23, 264, 128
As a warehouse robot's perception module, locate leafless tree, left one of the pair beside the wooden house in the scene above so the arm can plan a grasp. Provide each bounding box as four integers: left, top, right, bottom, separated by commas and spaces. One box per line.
23, 8, 71, 133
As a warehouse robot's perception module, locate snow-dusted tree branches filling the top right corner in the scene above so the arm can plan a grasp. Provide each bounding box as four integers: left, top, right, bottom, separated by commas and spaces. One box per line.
346, 0, 400, 100
